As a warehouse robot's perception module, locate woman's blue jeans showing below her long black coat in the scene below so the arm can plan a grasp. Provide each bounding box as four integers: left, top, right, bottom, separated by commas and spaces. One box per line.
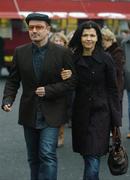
83, 155, 100, 180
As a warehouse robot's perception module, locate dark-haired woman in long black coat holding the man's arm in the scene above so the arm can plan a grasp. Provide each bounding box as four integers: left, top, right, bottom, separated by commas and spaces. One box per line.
61, 21, 121, 180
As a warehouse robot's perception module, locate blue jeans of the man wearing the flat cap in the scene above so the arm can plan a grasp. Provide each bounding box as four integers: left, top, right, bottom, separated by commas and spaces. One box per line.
24, 126, 59, 180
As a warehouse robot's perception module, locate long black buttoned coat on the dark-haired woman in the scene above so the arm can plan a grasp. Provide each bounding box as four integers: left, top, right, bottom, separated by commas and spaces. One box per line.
72, 51, 121, 155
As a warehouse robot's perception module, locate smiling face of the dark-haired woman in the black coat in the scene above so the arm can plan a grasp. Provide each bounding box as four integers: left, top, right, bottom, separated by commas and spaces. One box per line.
81, 28, 98, 50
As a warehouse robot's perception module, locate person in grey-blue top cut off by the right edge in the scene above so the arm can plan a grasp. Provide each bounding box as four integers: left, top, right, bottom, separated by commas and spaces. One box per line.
121, 34, 130, 139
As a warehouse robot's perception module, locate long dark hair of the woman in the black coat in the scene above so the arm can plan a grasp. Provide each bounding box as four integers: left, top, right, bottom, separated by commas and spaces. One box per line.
68, 21, 102, 54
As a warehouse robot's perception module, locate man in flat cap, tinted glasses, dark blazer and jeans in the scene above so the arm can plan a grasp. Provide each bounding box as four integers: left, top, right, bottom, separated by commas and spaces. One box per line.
2, 13, 76, 180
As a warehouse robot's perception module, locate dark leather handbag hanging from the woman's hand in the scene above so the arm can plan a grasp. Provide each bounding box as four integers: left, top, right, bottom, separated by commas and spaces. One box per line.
108, 128, 128, 176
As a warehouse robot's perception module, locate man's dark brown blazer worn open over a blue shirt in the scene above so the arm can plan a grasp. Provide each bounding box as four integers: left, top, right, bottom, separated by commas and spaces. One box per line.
2, 42, 76, 127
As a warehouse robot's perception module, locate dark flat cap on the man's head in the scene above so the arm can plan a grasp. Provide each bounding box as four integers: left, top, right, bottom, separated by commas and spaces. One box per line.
25, 13, 51, 25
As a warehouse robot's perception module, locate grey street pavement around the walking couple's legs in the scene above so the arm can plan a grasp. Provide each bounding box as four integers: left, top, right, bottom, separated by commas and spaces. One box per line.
0, 77, 130, 180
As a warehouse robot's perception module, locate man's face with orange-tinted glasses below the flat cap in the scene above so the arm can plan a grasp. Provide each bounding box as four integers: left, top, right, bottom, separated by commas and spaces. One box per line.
28, 20, 50, 43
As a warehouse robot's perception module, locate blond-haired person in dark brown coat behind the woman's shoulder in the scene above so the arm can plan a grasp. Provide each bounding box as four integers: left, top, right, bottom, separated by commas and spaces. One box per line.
101, 27, 125, 115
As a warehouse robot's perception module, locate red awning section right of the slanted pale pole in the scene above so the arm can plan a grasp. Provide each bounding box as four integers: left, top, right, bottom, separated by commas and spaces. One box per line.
17, 0, 130, 14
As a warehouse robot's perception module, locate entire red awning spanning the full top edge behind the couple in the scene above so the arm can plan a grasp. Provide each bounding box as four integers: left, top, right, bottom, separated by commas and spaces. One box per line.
0, 0, 130, 19
